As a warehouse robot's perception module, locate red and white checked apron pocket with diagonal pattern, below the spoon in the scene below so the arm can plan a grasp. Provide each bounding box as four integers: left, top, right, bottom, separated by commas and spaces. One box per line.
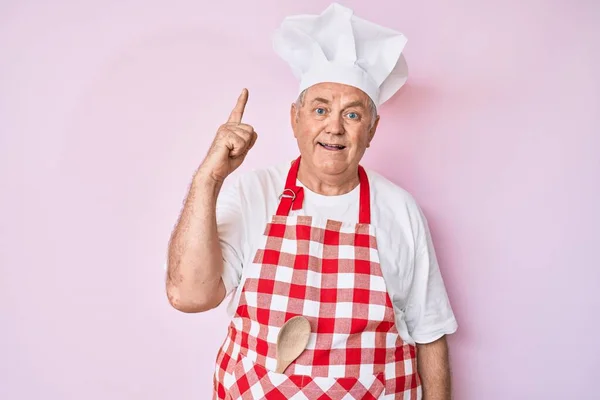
227, 354, 385, 399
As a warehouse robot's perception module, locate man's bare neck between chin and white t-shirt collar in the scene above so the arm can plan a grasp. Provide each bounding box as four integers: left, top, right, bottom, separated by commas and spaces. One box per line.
298, 162, 359, 196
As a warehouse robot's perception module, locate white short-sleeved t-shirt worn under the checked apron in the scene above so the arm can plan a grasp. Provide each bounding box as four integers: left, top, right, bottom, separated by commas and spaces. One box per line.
217, 163, 457, 344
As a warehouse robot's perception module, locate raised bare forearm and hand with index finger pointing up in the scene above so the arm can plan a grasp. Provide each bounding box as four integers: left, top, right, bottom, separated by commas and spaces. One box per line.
166, 89, 257, 312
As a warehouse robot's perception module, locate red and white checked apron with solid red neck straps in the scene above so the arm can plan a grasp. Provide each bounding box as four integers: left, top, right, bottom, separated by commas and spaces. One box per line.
213, 158, 422, 400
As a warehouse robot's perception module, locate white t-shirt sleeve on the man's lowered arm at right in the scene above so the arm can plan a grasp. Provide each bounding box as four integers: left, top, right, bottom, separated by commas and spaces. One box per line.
405, 206, 458, 343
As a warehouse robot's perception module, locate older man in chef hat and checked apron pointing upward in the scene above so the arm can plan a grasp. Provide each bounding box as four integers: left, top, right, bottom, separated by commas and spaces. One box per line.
167, 3, 457, 400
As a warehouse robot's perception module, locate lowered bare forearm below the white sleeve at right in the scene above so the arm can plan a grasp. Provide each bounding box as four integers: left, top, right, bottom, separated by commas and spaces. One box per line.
417, 336, 452, 400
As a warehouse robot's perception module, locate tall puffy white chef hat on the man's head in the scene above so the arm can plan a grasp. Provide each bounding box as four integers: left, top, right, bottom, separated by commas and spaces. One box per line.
273, 3, 408, 106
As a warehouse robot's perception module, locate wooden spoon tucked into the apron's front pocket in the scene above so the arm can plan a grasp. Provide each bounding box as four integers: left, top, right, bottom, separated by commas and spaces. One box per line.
275, 316, 310, 374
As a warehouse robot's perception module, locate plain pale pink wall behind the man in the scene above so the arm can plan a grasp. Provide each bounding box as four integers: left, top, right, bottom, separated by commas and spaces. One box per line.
0, 0, 600, 400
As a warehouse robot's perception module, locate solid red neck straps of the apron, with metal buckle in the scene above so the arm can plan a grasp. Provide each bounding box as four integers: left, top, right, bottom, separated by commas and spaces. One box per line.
277, 157, 371, 224
